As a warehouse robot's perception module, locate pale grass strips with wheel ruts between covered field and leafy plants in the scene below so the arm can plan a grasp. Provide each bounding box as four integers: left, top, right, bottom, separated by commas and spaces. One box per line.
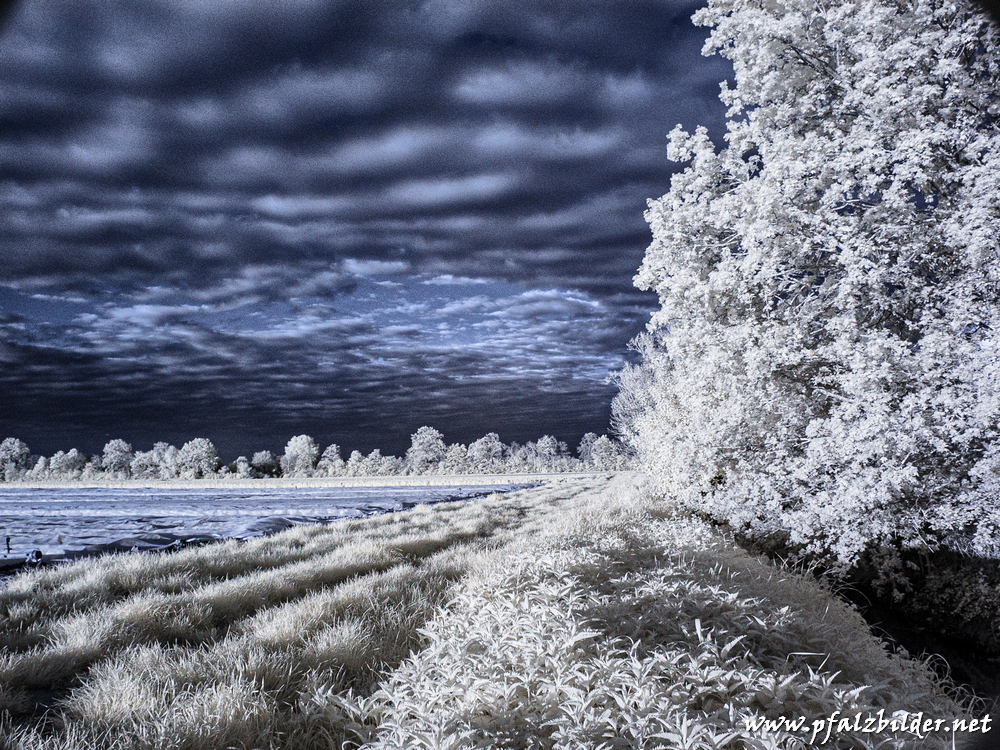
0, 478, 606, 748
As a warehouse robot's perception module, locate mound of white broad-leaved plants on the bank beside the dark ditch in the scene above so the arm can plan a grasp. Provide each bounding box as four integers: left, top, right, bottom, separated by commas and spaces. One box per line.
316, 482, 967, 750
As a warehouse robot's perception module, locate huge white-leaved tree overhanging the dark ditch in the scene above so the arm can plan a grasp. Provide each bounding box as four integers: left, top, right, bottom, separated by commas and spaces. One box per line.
614, 0, 1000, 565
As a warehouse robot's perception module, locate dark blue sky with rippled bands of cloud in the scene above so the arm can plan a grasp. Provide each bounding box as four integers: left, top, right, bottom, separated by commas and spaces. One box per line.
0, 0, 731, 460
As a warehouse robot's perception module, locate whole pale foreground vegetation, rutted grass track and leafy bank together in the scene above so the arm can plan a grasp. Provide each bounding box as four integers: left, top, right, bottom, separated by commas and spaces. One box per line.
0, 475, 968, 750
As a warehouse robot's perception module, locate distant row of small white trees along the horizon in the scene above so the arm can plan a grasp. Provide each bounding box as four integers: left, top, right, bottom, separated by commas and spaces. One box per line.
0, 427, 628, 482
